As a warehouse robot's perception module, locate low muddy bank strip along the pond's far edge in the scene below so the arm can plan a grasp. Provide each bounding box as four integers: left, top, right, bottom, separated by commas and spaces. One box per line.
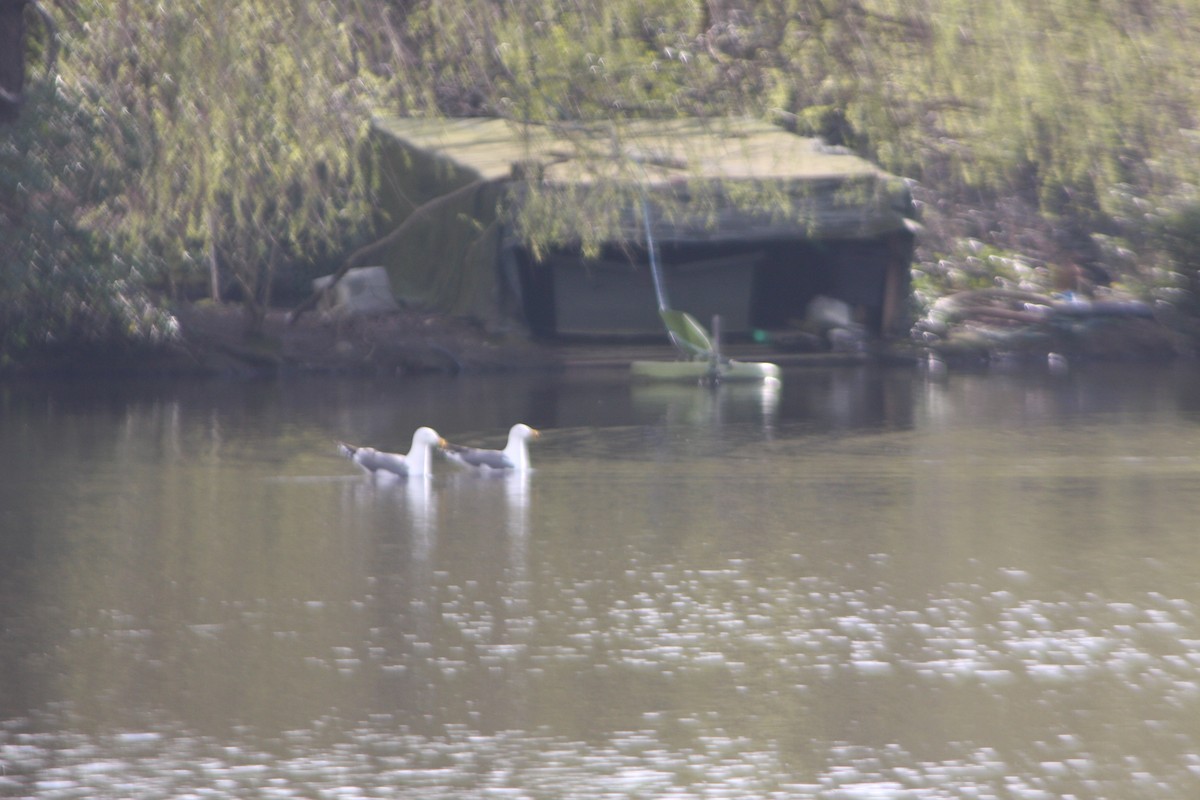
0, 292, 1193, 378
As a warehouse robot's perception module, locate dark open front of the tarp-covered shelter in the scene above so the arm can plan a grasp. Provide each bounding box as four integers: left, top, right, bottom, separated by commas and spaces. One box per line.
517, 231, 912, 339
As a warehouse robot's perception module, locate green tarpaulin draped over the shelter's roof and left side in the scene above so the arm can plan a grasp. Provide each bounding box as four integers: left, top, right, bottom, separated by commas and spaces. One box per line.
372, 116, 911, 331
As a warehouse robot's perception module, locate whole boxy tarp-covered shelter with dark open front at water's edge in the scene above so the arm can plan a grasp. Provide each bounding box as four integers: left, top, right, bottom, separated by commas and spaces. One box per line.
372, 118, 914, 336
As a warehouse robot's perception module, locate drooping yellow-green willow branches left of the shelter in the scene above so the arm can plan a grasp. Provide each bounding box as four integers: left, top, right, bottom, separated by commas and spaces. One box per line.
68, 0, 386, 321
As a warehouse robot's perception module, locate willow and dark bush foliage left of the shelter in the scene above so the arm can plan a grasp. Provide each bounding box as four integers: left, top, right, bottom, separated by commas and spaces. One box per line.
0, 0, 393, 357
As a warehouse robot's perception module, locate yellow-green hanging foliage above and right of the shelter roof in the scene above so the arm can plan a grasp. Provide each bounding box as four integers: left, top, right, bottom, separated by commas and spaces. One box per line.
388, 0, 1200, 284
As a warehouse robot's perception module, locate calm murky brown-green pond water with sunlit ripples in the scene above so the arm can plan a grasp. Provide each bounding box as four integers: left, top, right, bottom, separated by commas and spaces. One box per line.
0, 365, 1200, 800
